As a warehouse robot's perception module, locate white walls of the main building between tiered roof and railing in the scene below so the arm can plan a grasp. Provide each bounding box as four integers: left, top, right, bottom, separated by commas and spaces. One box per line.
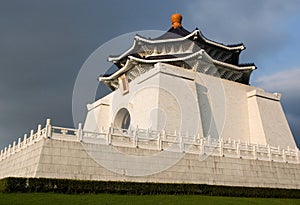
84, 63, 296, 148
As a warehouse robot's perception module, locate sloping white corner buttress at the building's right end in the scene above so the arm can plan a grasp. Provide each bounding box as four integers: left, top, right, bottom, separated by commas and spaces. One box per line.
247, 90, 296, 147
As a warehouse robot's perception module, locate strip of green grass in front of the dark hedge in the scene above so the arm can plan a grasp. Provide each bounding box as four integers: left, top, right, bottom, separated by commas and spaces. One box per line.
0, 193, 300, 205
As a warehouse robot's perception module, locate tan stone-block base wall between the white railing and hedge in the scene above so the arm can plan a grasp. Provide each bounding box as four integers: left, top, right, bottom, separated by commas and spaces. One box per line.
0, 138, 300, 189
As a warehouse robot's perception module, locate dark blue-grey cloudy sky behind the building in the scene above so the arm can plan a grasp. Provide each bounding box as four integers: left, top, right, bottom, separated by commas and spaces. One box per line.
0, 0, 300, 148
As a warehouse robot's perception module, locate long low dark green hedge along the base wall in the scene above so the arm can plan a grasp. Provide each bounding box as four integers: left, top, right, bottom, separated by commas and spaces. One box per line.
0, 177, 300, 198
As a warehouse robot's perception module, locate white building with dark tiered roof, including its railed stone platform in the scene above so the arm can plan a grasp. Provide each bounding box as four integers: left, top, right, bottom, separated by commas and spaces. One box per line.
0, 14, 300, 189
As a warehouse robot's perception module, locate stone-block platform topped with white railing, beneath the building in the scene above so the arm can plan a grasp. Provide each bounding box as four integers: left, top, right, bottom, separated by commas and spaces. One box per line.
0, 121, 300, 189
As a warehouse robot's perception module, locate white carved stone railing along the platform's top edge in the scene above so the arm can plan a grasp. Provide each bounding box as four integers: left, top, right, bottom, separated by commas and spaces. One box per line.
0, 119, 300, 164
